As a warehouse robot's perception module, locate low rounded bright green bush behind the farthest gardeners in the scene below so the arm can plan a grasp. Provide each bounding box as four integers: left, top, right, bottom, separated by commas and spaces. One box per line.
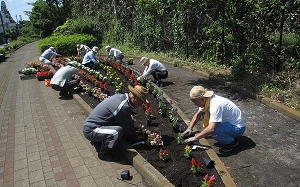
38, 34, 97, 56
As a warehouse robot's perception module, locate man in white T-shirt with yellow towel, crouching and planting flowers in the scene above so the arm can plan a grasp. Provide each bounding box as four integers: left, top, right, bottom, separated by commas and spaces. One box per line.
182, 86, 246, 153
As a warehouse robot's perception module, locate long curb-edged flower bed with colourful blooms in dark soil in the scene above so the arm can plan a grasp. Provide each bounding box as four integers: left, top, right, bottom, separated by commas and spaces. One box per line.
54, 57, 224, 187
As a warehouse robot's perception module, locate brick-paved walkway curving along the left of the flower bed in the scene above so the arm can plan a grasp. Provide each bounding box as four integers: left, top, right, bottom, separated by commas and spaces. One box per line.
0, 42, 149, 187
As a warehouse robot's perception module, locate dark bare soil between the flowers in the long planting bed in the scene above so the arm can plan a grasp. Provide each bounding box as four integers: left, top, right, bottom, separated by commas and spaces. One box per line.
73, 63, 225, 187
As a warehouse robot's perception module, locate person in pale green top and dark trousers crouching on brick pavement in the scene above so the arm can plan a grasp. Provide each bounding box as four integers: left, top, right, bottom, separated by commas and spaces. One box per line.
50, 61, 85, 98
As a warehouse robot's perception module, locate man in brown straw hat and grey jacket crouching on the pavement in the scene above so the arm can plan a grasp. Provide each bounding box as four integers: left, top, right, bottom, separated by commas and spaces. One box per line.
83, 85, 148, 162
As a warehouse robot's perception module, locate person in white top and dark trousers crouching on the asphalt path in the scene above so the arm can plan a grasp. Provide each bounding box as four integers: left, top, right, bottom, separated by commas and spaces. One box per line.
137, 57, 168, 84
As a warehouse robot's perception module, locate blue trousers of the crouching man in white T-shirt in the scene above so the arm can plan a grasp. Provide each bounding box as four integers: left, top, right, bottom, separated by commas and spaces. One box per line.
212, 122, 246, 144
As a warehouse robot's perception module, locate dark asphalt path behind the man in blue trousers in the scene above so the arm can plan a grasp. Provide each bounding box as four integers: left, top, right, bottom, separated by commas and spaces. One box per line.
131, 58, 300, 187
